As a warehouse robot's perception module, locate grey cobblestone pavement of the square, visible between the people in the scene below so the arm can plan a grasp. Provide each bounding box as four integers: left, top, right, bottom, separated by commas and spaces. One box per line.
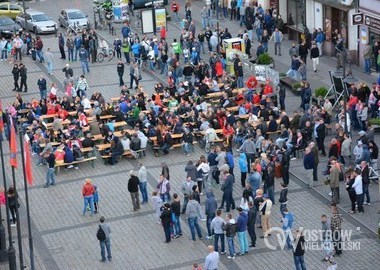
0, 0, 380, 270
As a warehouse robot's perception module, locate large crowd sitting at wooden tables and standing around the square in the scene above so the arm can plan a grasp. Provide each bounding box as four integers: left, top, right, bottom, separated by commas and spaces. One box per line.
0, 0, 380, 269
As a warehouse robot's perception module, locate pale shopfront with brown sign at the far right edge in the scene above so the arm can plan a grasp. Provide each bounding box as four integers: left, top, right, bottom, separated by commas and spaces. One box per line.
359, 0, 380, 69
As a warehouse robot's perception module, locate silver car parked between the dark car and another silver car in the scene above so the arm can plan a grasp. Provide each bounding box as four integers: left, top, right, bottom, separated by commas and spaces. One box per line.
16, 9, 58, 34
